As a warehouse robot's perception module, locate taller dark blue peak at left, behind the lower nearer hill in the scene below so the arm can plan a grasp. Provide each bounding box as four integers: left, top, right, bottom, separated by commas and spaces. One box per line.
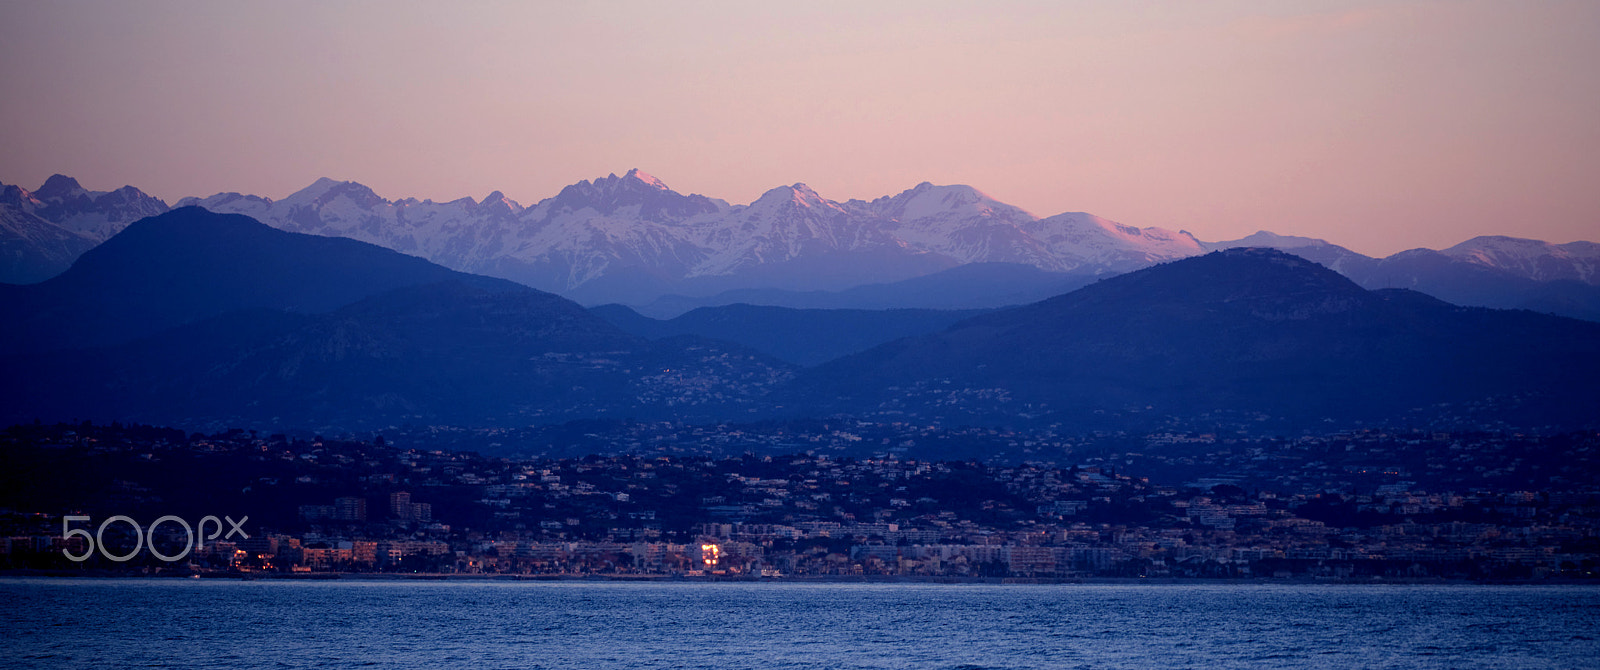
0, 208, 518, 352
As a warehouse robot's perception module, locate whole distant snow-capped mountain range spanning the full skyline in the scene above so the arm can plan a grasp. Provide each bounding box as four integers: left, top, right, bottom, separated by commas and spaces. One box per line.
0, 169, 1600, 321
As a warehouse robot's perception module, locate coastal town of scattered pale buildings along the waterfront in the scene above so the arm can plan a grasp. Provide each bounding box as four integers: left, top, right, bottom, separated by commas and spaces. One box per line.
0, 419, 1600, 580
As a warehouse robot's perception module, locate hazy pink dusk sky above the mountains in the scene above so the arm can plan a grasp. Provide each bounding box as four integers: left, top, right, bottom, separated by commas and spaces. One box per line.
0, 0, 1600, 256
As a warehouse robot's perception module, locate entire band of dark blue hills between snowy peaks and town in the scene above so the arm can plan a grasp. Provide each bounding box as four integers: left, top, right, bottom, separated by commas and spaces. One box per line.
0, 208, 1600, 430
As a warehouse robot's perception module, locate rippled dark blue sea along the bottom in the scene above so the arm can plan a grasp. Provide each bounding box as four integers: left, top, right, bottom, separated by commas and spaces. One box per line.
0, 579, 1600, 670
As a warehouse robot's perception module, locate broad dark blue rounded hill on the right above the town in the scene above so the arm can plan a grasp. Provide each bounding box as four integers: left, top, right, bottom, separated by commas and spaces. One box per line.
797, 249, 1600, 425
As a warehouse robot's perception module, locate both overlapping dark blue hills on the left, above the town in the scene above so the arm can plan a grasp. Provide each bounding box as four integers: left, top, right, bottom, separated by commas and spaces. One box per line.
0, 208, 790, 430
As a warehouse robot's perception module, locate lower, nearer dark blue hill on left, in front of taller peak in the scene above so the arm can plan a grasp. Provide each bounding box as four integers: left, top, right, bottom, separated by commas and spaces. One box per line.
0, 281, 787, 430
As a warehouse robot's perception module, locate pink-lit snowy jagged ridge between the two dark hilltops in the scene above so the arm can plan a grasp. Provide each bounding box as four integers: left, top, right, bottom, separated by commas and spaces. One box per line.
181, 169, 1200, 304
